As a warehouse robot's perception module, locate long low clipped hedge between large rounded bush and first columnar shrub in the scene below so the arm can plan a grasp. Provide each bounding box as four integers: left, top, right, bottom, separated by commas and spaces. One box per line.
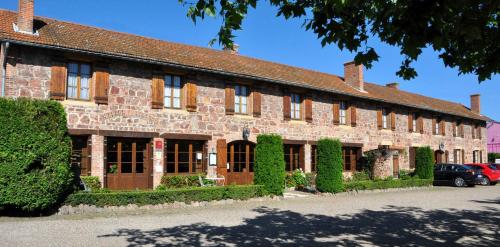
65, 185, 267, 207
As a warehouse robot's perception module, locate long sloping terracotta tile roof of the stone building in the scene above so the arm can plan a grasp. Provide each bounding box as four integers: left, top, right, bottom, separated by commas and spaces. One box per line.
0, 10, 486, 120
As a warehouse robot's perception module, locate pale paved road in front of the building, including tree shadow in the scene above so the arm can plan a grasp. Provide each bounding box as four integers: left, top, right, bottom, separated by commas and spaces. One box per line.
0, 186, 500, 246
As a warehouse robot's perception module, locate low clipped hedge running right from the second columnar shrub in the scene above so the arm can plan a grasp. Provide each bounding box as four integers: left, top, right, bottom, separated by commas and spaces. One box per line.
344, 178, 432, 191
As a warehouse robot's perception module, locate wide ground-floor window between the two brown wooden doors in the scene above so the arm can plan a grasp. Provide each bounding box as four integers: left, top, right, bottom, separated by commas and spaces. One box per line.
165, 140, 205, 174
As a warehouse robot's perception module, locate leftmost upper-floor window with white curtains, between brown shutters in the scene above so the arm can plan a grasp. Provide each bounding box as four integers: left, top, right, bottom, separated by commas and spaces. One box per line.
66, 62, 92, 100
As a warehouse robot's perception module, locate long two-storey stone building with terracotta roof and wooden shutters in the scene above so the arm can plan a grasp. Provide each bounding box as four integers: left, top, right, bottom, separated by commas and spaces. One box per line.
0, 0, 487, 189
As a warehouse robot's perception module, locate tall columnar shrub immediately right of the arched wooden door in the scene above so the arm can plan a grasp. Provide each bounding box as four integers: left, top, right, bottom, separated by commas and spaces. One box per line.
253, 134, 285, 195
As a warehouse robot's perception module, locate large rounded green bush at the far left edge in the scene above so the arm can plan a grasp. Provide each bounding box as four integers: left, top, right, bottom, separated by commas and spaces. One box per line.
0, 98, 77, 213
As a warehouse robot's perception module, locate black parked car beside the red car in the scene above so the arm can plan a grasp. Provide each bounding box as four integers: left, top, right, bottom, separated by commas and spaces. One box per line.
434, 164, 483, 187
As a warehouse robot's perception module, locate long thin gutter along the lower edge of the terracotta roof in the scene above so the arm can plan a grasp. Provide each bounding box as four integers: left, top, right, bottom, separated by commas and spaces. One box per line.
2, 39, 486, 121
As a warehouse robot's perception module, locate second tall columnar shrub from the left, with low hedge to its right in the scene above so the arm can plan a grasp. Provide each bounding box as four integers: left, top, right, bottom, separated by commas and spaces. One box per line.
316, 139, 343, 193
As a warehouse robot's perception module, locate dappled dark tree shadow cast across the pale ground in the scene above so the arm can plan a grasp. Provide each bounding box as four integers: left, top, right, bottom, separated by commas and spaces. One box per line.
99, 202, 500, 246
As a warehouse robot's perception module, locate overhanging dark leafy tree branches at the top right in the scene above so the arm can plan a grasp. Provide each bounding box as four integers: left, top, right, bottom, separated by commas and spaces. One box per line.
179, 0, 500, 81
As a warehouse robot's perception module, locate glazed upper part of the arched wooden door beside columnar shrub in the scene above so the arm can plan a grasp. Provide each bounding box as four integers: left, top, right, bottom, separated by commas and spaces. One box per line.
227, 141, 255, 172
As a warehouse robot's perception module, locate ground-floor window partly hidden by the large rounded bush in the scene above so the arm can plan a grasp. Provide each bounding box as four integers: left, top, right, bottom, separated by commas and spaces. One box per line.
71, 136, 91, 176
